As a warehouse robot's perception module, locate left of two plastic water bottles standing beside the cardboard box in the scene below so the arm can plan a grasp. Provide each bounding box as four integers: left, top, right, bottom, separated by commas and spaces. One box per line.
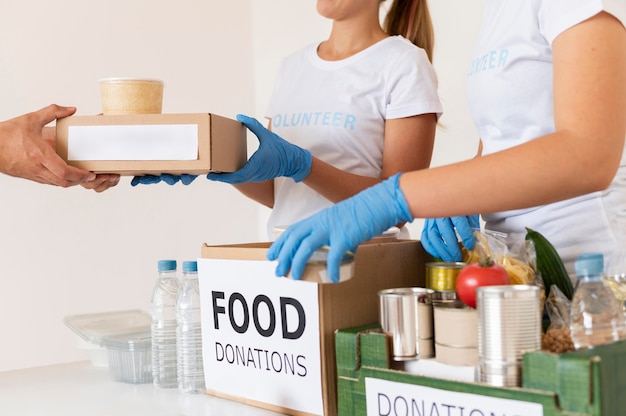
150, 260, 180, 388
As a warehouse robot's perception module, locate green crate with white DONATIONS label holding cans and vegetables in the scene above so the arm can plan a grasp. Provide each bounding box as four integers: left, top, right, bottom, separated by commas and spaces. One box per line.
335, 324, 626, 416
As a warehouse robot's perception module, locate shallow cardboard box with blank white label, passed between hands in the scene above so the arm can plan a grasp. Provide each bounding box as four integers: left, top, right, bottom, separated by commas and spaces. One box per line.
56, 113, 247, 176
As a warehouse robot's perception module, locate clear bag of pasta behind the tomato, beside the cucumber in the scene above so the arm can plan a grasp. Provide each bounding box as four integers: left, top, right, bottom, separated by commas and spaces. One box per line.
463, 230, 542, 286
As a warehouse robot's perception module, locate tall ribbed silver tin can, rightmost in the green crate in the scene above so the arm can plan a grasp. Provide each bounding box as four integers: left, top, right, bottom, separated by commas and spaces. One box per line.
476, 285, 541, 387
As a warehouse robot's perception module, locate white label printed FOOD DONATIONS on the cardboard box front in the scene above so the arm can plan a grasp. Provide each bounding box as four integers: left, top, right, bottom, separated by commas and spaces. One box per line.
198, 258, 323, 415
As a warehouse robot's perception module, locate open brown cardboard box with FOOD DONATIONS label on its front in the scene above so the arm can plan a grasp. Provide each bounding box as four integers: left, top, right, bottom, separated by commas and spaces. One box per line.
198, 240, 426, 416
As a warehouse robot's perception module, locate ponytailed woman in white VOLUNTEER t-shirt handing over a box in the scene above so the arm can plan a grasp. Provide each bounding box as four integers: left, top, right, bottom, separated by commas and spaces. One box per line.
208, 0, 442, 239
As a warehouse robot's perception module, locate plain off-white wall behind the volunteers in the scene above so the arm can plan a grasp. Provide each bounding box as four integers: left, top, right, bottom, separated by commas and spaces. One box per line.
0, 0, 482, 371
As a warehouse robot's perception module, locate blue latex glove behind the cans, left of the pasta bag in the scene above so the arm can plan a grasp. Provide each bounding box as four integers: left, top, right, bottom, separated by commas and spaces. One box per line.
421, 215, 480, 261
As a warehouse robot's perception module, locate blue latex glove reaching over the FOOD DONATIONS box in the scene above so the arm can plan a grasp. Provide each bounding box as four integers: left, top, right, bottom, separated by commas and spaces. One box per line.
267, 174, 413, 283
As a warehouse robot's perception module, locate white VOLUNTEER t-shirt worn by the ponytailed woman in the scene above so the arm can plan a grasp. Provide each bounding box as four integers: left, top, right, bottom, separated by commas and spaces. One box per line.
266, 36, 442, 239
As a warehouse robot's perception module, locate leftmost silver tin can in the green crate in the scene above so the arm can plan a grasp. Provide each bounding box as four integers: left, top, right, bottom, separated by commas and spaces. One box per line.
378, 287, 435, 361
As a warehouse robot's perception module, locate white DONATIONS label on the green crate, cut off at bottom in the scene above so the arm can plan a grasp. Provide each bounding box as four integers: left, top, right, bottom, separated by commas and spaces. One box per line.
365, 378, 543, 416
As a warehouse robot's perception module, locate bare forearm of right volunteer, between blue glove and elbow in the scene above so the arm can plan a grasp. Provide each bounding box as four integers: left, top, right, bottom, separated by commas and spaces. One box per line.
400, 133, 624, 218
